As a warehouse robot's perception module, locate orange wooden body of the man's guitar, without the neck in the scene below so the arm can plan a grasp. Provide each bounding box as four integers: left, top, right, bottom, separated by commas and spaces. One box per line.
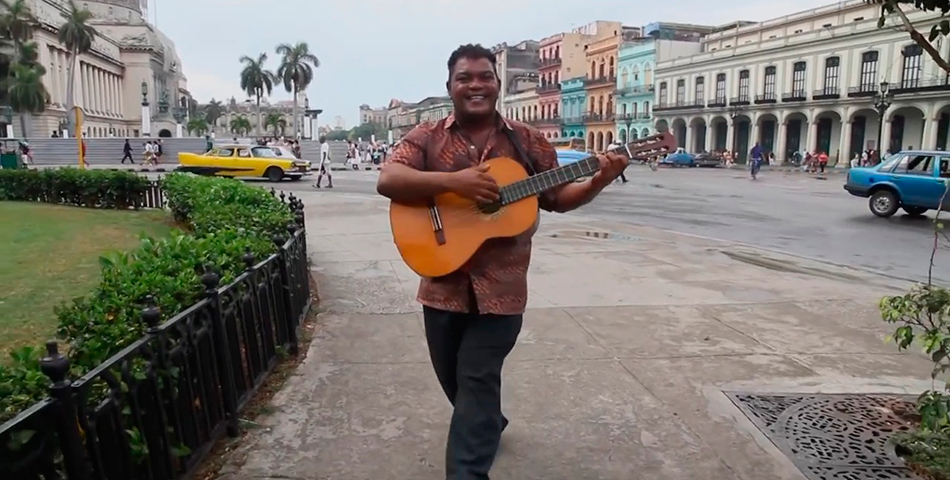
389, 158, 538, 277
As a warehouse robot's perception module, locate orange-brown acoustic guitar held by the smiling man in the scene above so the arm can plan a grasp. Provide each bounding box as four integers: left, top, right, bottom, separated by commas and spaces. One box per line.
389, 132, 677, 277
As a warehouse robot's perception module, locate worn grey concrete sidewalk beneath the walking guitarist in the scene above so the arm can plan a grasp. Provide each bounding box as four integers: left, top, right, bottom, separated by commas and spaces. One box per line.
216, 189, 930, 480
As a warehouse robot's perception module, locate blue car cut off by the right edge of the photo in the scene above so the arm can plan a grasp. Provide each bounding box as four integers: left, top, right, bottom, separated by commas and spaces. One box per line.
844, 150, 950, 218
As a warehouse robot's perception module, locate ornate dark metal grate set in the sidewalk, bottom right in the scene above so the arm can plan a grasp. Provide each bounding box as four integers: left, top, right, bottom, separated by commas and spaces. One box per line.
726, 392, 919, 480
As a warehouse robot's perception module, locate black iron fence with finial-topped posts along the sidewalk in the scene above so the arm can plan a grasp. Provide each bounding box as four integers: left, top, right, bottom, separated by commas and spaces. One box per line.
0, 188, 312, 480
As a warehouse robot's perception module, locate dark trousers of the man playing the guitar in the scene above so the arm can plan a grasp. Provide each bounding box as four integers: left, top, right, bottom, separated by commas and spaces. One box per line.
423, 307, 522, 480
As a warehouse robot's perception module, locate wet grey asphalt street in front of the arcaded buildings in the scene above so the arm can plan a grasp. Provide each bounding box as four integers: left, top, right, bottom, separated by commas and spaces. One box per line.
255, 166, 950, 283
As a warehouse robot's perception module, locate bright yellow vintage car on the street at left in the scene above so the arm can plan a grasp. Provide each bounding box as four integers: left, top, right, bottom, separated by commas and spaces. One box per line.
177, 145, 311, 182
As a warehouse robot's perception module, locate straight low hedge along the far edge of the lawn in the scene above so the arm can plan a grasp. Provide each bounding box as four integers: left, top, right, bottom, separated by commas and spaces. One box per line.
0, 168, 151, 208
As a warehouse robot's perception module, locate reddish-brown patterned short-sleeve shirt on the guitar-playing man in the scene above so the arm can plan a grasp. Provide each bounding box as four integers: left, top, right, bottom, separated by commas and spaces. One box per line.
384, 115, 558, 315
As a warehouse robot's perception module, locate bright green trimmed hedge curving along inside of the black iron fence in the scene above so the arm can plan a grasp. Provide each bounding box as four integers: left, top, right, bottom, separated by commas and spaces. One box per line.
0, 169, 294, 422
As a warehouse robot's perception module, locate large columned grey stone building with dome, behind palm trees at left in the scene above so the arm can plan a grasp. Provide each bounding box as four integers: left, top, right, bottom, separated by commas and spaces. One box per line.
13, 0, 194, 137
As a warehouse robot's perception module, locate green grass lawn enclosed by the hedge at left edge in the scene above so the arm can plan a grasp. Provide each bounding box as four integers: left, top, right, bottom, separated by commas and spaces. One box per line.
0, 202, 174, 362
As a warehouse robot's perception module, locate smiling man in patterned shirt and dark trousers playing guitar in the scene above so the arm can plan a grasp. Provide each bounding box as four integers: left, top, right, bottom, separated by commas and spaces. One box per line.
377, 44, 628, 480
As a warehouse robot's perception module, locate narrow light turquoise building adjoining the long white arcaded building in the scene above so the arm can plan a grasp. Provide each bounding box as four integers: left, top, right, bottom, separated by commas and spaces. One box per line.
614, 37, 656, 142
